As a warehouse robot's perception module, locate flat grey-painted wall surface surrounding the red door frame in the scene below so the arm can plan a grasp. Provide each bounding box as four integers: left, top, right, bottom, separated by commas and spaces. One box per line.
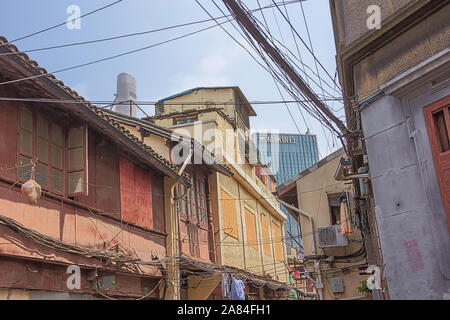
361, 54, 450, 299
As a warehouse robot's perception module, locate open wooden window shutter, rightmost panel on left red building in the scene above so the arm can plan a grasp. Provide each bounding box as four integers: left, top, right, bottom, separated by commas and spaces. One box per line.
66, 125, 88, 197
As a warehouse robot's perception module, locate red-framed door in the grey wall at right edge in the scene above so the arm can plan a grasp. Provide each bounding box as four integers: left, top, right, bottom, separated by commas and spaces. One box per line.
424, 96, 450, 231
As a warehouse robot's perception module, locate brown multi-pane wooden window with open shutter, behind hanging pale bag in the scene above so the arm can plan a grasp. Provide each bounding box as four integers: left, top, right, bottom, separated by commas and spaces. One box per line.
18, 108, 87, 197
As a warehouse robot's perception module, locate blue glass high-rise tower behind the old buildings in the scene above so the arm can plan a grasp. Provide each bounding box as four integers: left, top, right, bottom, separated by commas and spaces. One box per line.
253, 133, 319, 254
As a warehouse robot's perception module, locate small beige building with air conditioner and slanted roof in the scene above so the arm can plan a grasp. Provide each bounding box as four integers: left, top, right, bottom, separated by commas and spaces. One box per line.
277, 149, 372, 300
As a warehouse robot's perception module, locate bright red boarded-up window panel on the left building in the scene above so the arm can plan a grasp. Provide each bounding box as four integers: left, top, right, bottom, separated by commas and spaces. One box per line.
119, 157, 153, 229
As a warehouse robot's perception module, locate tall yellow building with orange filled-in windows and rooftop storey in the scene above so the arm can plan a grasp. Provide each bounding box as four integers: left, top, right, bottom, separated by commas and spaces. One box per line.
150, 87, 288, 298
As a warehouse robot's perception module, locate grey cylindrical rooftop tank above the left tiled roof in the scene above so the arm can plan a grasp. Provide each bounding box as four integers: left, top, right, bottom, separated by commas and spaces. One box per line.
116, 73, 136, 117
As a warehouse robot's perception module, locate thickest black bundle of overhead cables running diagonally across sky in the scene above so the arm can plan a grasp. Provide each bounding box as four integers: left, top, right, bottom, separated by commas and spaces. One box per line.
223, 0, 349, 136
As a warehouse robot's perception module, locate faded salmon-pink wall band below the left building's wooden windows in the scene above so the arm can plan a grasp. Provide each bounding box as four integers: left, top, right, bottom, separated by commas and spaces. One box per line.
0, 183, 166, 273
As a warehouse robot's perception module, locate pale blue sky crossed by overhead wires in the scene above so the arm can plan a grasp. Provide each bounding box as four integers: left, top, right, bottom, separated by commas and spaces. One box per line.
0, 0, 343, 158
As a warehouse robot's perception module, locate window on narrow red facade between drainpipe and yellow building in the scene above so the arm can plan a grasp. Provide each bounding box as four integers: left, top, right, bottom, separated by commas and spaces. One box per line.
176, 174, 208, 224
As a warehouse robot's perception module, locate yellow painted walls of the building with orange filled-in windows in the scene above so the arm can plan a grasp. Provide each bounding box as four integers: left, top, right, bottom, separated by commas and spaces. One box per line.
155, 88, 288, 288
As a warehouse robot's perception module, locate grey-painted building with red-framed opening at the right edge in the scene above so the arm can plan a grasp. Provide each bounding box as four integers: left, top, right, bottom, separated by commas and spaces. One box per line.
330, 0, 450, 299
